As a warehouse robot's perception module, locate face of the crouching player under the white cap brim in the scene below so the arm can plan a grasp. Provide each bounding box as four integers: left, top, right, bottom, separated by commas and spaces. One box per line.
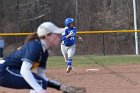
45, 33, 60, 46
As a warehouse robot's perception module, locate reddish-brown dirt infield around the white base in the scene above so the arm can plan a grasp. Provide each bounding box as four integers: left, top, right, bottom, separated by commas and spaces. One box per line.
0, 65, 140, 93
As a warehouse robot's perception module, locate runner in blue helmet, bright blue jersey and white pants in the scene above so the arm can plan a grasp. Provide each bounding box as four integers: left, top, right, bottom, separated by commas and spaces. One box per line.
61, 18, 83, 73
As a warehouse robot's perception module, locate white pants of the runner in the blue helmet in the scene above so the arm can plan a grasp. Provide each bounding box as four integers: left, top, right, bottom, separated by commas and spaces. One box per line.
61, 44, 75, 62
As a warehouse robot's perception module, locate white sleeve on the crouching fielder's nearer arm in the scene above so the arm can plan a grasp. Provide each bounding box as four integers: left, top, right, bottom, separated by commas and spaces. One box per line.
20, 61, 43, 92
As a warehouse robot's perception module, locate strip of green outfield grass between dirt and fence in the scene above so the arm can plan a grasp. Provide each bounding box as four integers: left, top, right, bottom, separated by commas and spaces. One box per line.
47, 55, 140, 68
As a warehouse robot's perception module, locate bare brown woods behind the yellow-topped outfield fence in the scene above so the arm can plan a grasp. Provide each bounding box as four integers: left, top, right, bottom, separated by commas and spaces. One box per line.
0, 0, 140, 55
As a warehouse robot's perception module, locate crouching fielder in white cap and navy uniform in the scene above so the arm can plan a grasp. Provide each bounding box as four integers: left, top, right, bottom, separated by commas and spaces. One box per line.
0, 22, 71, 93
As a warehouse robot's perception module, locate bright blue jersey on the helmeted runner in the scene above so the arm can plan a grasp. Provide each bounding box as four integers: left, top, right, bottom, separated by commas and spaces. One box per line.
61, 27, 77, 46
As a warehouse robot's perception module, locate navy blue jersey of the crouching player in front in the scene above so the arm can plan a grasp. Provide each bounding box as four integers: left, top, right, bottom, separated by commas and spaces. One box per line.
4, 39, 48, 69
